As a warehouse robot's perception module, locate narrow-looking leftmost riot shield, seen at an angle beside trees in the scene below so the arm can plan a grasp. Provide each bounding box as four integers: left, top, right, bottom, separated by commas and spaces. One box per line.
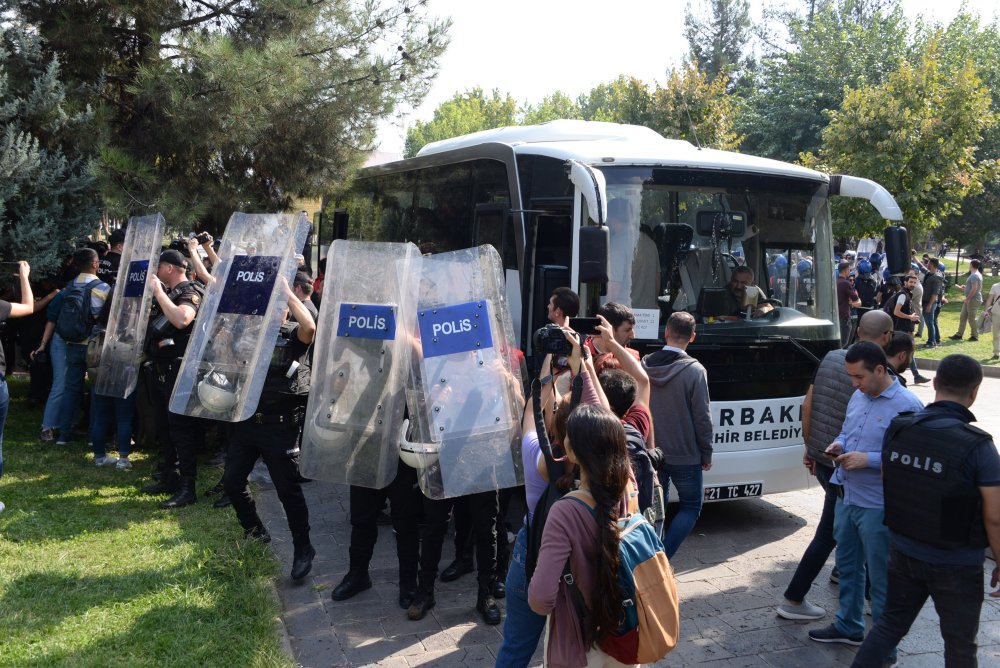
94, 213, 163, 399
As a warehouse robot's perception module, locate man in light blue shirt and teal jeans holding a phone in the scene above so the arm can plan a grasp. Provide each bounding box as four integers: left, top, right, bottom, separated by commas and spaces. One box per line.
809, 341, 923, 645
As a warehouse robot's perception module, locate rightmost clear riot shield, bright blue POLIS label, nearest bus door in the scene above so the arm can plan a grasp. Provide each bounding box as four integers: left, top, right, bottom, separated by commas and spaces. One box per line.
400, 246, 524, 499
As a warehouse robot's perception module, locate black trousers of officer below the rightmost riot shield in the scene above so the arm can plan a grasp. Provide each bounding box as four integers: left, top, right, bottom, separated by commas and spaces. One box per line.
420, 491, 499, 591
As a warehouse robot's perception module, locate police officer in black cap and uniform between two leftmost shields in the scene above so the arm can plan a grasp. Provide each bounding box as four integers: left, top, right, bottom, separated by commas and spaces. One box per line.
142, 249, 204, 508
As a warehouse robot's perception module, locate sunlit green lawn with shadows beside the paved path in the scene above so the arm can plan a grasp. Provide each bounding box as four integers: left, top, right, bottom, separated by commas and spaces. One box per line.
0, 379, 291, 667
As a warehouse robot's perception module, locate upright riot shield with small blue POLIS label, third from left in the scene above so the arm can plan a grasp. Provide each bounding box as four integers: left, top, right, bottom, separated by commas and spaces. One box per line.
300, 240, 420, 489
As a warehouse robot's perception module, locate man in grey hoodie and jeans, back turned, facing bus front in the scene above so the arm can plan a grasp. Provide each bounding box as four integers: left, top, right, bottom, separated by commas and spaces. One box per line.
642, 311, 712, 558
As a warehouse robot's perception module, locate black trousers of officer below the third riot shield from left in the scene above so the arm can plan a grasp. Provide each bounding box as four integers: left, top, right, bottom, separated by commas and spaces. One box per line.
350, 461, 424, 588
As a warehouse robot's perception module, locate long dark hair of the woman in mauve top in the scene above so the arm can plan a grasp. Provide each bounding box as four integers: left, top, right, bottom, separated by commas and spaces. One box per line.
566, 404, 629, 647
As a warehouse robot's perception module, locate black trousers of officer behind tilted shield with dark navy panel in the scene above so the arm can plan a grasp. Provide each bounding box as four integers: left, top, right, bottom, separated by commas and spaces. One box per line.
222, 418, 309, 537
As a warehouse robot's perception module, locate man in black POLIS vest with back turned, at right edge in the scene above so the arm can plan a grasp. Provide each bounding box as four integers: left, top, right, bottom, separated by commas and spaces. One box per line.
853, 355, 1000, 668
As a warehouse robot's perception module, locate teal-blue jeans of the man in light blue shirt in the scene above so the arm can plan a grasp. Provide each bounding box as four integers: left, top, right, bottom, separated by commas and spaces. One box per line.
833, 498, 889, 636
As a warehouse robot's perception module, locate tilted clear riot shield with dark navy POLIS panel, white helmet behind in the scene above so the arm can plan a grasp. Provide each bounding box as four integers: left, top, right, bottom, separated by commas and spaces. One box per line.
170, 213, 309, 422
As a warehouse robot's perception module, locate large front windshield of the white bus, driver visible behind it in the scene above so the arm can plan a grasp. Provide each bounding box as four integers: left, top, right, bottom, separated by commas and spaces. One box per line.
579, 166, 835, 321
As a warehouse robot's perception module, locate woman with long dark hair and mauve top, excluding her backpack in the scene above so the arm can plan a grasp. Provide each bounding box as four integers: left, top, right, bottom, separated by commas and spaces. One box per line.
528, 405, 630, 668
